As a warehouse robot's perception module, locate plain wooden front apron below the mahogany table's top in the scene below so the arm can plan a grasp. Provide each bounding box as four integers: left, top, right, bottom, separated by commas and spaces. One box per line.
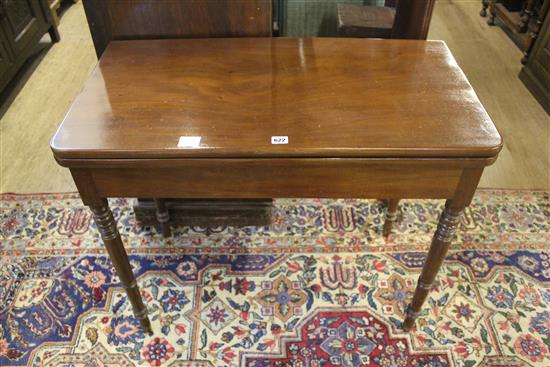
71, 159, 490, 201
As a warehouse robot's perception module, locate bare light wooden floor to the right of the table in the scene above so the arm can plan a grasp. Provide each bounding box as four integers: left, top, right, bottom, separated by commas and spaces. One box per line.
428, 0, 550, 189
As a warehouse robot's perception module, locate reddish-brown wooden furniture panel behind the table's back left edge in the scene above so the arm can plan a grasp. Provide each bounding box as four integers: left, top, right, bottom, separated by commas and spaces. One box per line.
83, 0, 272, 57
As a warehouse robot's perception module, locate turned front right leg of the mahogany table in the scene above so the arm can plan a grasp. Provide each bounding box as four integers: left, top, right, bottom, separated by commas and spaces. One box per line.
403, 200, 464, 331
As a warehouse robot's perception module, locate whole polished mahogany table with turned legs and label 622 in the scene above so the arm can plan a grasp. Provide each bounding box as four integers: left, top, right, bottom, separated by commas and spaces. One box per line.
51, 38, 502, 332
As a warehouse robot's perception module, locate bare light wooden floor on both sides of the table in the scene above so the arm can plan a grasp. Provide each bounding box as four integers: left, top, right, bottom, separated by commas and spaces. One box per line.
0, 0, 550, 193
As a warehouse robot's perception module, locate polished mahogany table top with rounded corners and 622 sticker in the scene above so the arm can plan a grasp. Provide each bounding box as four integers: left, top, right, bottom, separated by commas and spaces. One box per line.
51, 38, 501, 159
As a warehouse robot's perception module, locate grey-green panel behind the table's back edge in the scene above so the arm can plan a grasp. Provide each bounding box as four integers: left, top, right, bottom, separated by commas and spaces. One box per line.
279, 0, 384, 37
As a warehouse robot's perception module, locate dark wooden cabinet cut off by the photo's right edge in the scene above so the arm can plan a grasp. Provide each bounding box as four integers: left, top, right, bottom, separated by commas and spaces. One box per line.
519, 0, 550, 114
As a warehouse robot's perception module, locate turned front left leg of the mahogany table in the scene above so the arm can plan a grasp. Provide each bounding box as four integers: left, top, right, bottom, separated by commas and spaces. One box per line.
90, 199, 152, 334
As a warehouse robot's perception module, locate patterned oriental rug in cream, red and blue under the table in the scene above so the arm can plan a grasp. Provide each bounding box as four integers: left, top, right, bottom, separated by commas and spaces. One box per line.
0, 190, 550, 367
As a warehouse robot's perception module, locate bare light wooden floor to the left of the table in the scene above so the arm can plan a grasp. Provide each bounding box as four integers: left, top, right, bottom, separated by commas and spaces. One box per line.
0, 2, 97, 193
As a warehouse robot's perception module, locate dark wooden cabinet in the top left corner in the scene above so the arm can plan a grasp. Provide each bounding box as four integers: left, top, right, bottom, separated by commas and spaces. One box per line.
0, 0, 59, 92
